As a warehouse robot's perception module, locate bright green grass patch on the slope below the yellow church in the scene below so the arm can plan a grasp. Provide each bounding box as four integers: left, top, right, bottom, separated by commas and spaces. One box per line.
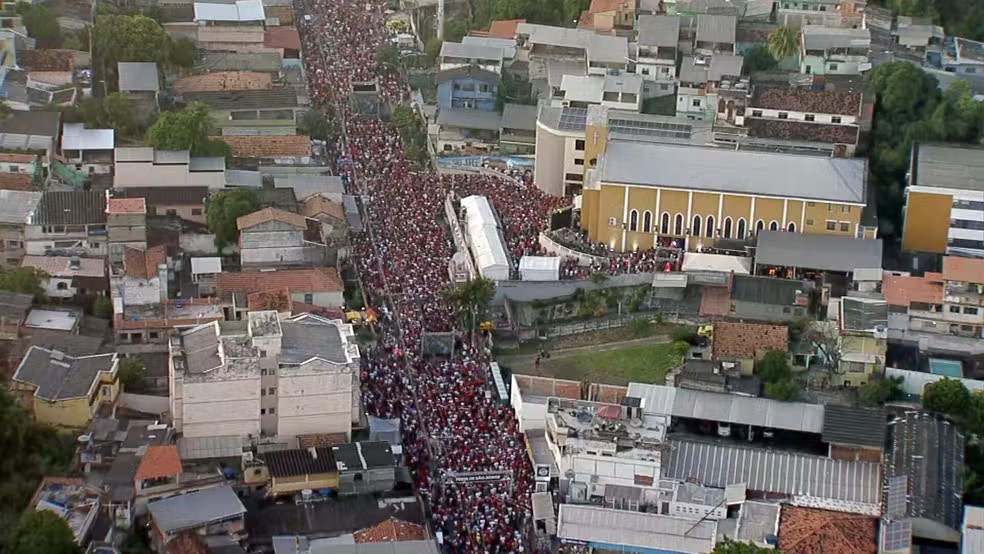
539, 343, 680, 385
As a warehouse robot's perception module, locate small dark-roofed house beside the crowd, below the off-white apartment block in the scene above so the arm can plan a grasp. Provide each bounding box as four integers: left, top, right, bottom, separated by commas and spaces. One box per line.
332, 442, 396, 495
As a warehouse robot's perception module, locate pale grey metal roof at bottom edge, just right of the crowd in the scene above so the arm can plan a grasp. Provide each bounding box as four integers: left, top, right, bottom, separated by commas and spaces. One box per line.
557, 504, 717, 553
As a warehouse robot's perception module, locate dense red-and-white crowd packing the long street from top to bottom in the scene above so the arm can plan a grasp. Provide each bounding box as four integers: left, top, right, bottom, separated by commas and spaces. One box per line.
302, 0, 532, 553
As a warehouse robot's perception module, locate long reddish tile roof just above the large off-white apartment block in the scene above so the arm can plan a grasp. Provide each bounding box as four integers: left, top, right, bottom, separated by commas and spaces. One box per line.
216, 267, 344, 297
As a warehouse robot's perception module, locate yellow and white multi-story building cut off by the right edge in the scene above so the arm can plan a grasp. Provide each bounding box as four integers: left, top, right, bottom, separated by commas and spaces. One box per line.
902, 143, 984, 258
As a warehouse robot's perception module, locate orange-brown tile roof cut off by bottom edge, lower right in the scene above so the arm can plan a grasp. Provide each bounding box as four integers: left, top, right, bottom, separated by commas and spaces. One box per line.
779, 505, 878, 554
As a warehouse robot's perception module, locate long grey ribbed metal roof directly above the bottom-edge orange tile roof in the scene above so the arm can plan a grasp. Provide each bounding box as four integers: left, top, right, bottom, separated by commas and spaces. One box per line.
661, 440, 881, 514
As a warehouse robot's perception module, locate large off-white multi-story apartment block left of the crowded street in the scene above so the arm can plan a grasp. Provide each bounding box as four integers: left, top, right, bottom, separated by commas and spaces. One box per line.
169, 311, 360, 438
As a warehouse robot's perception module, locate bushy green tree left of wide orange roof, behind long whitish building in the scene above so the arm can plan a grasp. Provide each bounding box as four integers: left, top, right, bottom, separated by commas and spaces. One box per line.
147, 102, 229, 157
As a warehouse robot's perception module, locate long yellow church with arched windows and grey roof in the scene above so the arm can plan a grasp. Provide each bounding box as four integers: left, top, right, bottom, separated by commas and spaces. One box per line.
576, 118, 867, 251
